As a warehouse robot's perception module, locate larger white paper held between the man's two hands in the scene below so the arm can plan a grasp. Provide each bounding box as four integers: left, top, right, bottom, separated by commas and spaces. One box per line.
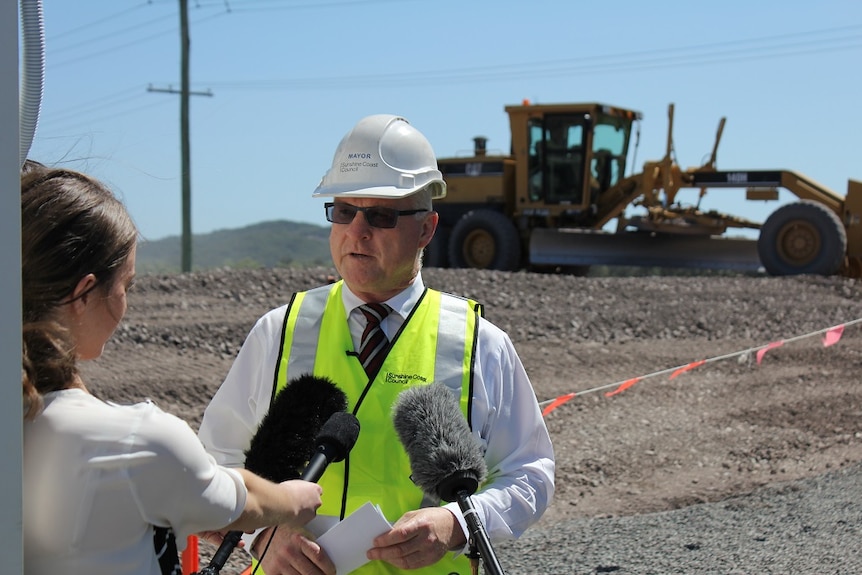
317, 501, 392, 575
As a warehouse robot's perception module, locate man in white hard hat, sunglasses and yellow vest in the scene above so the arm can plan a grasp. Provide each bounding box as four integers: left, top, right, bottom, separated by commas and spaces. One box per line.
200, 114, 554, 575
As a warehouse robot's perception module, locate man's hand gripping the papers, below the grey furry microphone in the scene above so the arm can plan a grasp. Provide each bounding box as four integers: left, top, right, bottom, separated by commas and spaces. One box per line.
368, 507, 467, 575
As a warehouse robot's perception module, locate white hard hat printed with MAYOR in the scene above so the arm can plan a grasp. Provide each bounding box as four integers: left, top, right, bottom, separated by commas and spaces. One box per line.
312, 114, 446, 199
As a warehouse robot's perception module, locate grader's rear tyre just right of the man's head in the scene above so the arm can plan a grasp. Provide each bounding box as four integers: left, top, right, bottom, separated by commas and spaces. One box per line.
449, 210, 521, 271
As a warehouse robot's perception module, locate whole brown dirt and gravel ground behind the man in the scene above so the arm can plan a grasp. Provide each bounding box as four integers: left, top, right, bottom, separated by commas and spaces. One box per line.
79, 268, 862, 575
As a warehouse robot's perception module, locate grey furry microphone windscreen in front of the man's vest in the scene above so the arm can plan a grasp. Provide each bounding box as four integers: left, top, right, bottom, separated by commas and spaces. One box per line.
392, 383, 488, 501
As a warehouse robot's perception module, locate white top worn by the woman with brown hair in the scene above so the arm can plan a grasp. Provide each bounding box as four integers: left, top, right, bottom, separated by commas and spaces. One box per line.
23, 389, 247, 575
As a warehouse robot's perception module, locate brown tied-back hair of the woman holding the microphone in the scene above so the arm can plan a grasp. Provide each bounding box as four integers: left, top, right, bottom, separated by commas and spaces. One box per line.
21, 161, 138, 418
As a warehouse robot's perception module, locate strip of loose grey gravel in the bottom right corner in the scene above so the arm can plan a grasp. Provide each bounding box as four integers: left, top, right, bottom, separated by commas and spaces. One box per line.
495, 464, 862, 575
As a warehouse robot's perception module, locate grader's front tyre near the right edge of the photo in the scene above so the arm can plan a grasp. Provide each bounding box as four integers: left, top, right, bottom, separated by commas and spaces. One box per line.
757, 200, 847, 276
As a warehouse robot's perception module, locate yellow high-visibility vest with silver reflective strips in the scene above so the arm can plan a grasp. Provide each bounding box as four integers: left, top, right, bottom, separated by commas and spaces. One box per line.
274, 281, 482, 575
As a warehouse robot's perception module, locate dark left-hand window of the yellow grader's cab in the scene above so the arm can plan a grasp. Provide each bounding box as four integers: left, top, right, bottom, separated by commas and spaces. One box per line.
528, 115, 584, 205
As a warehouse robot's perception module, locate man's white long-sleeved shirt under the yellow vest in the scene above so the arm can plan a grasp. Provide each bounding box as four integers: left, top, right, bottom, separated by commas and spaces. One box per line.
198, 275, 554, 540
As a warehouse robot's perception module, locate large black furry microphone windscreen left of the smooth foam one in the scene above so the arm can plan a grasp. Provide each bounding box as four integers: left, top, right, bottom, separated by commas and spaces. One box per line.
245, 374, 347, 482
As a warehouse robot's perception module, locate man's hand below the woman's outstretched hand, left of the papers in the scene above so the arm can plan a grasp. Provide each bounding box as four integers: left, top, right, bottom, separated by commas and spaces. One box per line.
254, 525, 335, 575
